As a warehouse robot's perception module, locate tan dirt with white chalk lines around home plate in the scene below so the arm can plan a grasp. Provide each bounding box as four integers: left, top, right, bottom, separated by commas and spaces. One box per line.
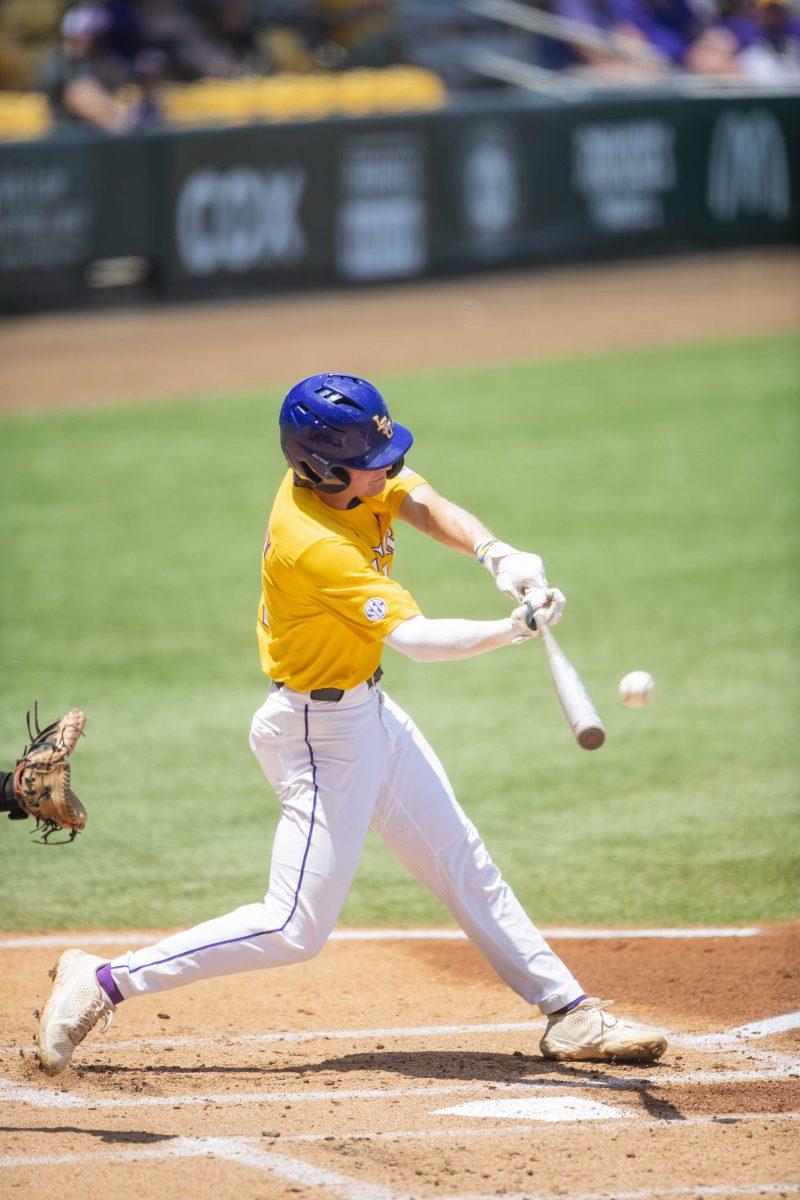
0, 925, 800, 1200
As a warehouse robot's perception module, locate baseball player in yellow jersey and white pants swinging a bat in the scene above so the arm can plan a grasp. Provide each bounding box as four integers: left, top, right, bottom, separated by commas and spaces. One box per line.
38, 374, 666, 1074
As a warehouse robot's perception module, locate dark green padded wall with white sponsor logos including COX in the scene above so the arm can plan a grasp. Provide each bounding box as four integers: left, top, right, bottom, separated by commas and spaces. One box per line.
0, 94, 800, 311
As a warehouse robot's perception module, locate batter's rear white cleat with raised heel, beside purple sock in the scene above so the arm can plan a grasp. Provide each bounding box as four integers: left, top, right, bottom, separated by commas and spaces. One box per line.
36, 950, 115, 1075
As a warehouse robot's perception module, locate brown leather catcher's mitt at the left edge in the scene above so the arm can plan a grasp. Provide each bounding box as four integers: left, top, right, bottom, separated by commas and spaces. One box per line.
14, 706, 86, 842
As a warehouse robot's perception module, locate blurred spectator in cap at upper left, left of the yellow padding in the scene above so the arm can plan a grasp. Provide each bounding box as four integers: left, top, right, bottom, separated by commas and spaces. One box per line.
41, 4, 133, 133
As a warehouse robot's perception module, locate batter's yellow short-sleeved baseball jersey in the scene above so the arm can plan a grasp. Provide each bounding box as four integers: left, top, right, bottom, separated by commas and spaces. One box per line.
257, 468, 425, 691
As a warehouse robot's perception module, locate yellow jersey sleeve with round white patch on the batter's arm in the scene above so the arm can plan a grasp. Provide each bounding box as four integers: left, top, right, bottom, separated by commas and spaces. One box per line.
295, 538, 420, 643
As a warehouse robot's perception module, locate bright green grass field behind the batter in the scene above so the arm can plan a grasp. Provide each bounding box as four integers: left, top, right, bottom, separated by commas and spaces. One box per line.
0, 337, 800, 929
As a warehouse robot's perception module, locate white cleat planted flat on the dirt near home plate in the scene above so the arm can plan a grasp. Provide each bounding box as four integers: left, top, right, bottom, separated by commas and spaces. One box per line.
539, 1000, 667, 1062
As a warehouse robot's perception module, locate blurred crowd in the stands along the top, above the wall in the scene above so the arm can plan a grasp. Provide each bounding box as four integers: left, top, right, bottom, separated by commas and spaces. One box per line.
0, 0, 800, 131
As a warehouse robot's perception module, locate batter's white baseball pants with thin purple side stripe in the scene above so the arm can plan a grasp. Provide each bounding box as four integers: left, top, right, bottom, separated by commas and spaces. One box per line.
110, 684, 582, 1013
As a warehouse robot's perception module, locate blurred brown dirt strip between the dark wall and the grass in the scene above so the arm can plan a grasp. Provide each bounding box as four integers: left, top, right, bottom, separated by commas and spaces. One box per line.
0, 247, 800, 412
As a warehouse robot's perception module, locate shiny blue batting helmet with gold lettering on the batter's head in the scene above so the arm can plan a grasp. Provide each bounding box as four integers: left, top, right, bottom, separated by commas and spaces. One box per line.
279, 374, 414, 492
